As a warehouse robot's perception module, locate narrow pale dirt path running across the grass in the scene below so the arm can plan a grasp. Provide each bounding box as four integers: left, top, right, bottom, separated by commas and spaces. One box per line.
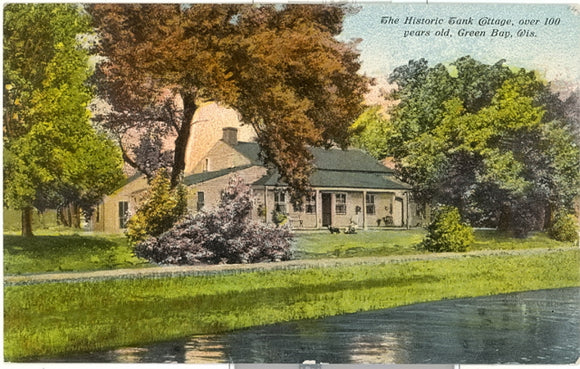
4, 247, 578, 286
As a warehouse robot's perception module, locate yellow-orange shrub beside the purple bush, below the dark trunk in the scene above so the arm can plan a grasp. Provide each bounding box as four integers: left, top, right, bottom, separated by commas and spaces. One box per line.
127, 169, 187, 244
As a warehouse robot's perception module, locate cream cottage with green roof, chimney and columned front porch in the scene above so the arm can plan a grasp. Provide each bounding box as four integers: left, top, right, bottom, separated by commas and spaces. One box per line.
93, 123, 425, 232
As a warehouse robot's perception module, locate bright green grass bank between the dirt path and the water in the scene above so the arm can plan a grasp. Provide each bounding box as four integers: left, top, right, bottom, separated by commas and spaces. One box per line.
4, 250, 580, 361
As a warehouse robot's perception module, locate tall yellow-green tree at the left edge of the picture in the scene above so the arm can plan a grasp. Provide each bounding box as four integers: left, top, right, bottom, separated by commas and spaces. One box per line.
3, 4, 123, 235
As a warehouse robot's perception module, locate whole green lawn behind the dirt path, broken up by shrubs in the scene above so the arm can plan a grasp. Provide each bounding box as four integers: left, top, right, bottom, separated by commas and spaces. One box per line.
4, 229, 567, 275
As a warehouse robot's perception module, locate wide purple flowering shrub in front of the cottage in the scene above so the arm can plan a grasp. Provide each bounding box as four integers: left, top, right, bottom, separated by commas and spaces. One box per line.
135, 176, 293, 265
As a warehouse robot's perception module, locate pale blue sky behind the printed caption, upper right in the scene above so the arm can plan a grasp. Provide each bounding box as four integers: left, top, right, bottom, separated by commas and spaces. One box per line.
339, 3, 580, 84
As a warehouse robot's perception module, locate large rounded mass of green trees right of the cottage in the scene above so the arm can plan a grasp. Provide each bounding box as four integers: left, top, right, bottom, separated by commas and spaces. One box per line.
387, 57, 580, 236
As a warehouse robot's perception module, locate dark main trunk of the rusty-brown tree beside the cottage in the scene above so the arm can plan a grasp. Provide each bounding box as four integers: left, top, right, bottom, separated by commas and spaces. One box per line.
171, 92, 197, 188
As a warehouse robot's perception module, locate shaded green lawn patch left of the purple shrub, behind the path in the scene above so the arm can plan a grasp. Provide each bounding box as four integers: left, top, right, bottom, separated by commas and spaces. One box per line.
4, 231, 150, 275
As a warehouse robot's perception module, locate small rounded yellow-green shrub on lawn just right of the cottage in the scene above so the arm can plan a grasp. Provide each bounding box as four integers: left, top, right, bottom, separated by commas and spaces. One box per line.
421, 206, 474, 252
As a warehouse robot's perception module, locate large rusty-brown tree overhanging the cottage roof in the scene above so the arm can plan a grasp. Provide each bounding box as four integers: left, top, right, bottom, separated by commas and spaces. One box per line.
88, 4, 367, 198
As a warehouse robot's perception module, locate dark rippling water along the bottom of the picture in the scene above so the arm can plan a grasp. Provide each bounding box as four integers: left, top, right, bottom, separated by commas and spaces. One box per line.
58, 288, 580, 364
